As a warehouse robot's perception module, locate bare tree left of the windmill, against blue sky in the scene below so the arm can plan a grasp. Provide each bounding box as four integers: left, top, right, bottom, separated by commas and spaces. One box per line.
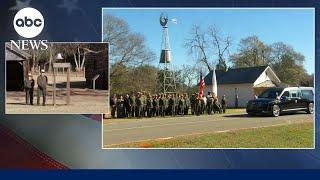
103, 14, 155, 76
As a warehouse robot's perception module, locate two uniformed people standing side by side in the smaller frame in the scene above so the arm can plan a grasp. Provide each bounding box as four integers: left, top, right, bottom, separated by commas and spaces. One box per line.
24, 69, 48, 106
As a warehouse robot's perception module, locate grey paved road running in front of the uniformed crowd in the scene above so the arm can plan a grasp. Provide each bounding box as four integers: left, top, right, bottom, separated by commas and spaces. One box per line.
103, 113, 313, 147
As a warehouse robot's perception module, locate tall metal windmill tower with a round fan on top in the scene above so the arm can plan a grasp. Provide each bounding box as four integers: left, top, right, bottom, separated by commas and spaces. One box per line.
159, 13, 176, 93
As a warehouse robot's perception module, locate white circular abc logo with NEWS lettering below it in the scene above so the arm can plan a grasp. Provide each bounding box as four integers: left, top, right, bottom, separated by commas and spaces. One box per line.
10, 7, 48, 50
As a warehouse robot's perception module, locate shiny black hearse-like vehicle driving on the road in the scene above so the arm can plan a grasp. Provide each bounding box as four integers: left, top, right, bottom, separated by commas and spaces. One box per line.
246, 87, 314, 117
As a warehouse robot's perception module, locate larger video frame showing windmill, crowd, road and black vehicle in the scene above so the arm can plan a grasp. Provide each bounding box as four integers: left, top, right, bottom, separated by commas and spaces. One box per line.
102, 8, 315, 149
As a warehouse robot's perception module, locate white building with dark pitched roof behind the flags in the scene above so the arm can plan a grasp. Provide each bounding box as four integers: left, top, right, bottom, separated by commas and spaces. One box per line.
204, 66, 281, 107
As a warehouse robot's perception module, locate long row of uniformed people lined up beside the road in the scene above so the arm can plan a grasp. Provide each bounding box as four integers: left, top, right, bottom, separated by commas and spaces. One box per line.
110, 92, 227, 118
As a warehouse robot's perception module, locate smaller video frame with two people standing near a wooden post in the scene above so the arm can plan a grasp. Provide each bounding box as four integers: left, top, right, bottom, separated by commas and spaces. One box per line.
5, 42, 109, 114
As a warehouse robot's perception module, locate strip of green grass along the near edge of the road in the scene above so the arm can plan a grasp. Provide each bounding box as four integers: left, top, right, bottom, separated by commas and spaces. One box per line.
111, 123, 314, 148
